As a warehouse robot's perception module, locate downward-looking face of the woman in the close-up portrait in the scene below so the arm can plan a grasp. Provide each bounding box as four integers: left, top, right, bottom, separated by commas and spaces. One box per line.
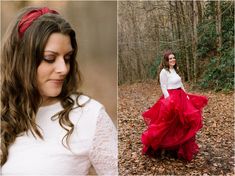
37, 33, 73, 102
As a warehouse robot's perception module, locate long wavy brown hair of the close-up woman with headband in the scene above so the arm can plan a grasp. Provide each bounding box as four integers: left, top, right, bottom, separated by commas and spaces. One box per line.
1, 7, 81, 165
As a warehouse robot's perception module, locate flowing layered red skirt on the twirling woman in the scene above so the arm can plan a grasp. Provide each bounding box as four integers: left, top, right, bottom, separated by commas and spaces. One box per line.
141, 88, 208, 161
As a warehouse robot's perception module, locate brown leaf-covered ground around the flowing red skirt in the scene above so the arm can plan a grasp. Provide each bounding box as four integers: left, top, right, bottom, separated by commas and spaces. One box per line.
118, 81, 235, 176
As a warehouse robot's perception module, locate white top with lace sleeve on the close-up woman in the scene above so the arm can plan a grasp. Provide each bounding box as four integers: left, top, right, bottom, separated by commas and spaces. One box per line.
2, 96, 118, 176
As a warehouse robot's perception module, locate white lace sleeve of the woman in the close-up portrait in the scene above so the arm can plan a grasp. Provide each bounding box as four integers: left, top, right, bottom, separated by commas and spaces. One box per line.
89, 108, 118, 175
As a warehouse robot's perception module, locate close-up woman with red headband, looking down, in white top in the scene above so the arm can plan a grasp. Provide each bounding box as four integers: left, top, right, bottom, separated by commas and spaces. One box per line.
1, 7, 117, 175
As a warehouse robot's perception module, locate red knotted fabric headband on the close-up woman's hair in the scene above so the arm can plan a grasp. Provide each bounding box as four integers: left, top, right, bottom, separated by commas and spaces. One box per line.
18, 7, 59, 38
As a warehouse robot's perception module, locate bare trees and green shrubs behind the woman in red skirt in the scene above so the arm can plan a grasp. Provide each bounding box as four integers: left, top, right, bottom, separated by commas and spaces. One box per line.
118, 1, 234, 91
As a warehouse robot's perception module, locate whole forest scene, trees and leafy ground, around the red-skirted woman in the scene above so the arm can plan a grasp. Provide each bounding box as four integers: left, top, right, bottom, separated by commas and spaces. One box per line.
118, 0, 235, 176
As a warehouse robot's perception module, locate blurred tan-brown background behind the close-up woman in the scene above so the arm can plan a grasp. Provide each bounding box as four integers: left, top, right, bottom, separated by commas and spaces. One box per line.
1, 1, 117, 125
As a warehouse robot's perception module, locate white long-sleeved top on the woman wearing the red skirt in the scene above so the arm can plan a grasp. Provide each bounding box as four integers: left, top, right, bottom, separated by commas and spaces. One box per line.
160, 69, 185, 98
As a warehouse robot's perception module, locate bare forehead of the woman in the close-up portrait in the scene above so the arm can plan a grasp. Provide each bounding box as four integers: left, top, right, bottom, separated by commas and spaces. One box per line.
44, 33, 73, 53
